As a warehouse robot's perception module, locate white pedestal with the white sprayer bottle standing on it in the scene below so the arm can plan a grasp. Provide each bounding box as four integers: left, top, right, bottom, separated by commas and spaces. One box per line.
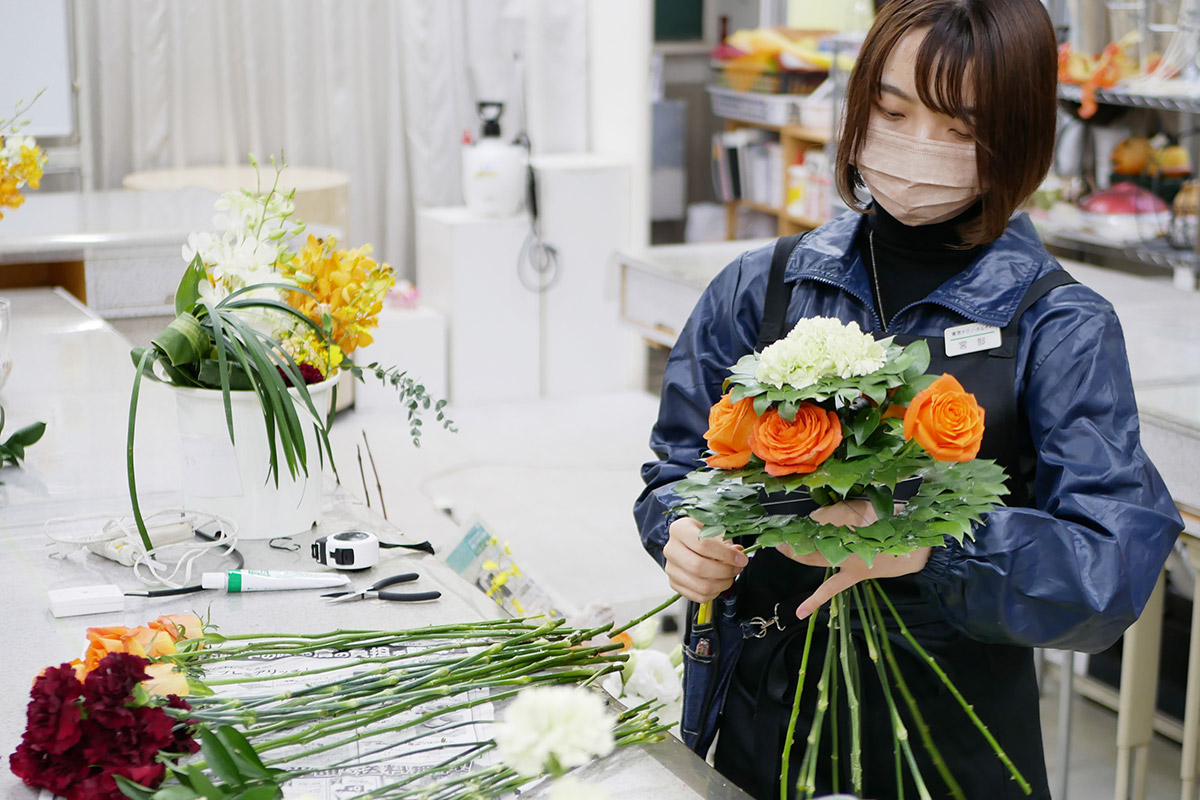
416, 207, 539, 407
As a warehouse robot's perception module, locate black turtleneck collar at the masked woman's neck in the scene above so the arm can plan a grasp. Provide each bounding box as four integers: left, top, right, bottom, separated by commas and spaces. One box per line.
858, 203, 983, 335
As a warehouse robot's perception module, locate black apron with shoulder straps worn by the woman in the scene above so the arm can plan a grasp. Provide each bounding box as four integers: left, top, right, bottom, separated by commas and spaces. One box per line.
715, 237, 1075, 800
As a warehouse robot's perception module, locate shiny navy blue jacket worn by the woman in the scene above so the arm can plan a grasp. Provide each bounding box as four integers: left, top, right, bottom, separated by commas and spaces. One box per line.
634, 211, 1183, 652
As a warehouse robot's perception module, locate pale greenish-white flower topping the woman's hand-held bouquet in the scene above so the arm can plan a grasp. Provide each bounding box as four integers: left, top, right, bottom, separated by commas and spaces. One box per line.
756, 317, 886, 389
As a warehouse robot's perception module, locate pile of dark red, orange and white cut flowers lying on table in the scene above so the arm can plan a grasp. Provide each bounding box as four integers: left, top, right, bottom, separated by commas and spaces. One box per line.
8, 607, 670, 800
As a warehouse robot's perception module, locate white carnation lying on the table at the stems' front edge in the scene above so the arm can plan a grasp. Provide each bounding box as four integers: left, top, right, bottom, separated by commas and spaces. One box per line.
494, 686, 616, 777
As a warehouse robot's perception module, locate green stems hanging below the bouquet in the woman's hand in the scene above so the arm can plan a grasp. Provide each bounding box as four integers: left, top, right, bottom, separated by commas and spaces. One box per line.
779, 581, 1032, 800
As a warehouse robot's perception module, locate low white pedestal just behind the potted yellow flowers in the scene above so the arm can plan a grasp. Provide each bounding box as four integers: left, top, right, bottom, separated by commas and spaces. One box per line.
354, 306, 446, 414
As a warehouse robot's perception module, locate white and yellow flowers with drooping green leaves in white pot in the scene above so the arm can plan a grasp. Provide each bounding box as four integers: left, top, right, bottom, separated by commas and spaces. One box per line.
127, 157, 454, 553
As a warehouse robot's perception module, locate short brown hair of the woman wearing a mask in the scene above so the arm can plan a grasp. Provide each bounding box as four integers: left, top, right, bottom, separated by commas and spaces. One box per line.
835, 0, 1057, 245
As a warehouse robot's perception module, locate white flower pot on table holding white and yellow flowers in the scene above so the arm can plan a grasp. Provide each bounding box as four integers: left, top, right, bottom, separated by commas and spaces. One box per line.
173, 378, 337, 540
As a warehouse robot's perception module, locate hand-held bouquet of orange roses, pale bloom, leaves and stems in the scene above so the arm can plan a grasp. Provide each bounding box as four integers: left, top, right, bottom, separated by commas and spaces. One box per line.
672, 318, 1030, 798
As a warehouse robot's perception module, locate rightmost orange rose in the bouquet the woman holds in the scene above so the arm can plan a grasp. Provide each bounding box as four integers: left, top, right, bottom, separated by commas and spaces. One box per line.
904, 374, 983, 462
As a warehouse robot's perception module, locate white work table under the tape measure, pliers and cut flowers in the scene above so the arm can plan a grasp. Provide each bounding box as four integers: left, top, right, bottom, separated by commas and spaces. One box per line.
0, 289, 746, 800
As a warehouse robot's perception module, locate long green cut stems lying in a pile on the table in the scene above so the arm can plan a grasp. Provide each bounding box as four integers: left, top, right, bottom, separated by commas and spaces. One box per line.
153, 607, 670, 800
